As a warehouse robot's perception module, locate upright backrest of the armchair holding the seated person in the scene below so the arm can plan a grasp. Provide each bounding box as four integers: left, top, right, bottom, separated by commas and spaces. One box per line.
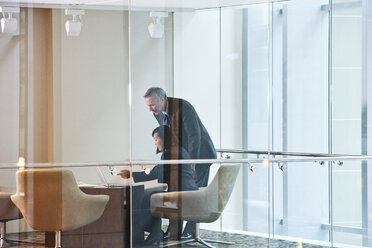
204, 164, 240, 219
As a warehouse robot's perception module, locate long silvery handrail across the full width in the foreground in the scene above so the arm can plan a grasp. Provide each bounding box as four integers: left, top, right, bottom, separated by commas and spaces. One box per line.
0, 155, 372, 169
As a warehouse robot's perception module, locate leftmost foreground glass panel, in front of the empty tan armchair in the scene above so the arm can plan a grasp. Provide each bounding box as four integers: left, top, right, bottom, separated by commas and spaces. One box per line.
0, 3, 130, 247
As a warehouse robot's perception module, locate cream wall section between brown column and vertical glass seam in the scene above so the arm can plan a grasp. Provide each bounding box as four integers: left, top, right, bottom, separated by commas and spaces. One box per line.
53, 10, 130, 183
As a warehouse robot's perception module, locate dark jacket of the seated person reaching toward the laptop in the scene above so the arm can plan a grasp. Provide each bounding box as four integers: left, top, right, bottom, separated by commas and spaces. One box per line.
133, 147, 199, 191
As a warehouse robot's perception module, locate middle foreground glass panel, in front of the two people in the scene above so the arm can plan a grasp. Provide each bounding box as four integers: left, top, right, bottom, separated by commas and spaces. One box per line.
131, 1, 269, 245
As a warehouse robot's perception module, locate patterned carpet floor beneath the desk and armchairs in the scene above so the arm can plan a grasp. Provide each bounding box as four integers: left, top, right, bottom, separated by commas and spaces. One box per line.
4, 230, 323, 248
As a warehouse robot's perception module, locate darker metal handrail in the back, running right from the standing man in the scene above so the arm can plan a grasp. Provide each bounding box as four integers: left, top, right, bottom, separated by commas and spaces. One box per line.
216, 149, 356, 157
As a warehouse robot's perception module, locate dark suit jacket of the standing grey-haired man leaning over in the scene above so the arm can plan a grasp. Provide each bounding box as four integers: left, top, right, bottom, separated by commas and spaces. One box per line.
154, 97, 217, 159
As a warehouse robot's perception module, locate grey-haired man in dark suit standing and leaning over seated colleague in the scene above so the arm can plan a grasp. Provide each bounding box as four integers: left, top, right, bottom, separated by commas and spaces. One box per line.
144, 87, 217, 237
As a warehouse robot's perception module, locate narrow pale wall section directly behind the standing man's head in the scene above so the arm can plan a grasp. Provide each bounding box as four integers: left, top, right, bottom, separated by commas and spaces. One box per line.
131, 11, 173, 159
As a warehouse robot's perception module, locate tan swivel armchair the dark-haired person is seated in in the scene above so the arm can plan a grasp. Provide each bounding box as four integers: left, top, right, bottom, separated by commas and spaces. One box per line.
151, 164, 240, 247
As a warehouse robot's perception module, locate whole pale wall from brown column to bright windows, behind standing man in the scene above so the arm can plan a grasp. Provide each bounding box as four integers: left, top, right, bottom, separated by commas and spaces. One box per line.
53, 10, 173, 183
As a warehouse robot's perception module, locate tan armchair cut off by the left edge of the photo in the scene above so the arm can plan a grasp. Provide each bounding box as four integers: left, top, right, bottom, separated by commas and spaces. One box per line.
0, 192, 23, 247
